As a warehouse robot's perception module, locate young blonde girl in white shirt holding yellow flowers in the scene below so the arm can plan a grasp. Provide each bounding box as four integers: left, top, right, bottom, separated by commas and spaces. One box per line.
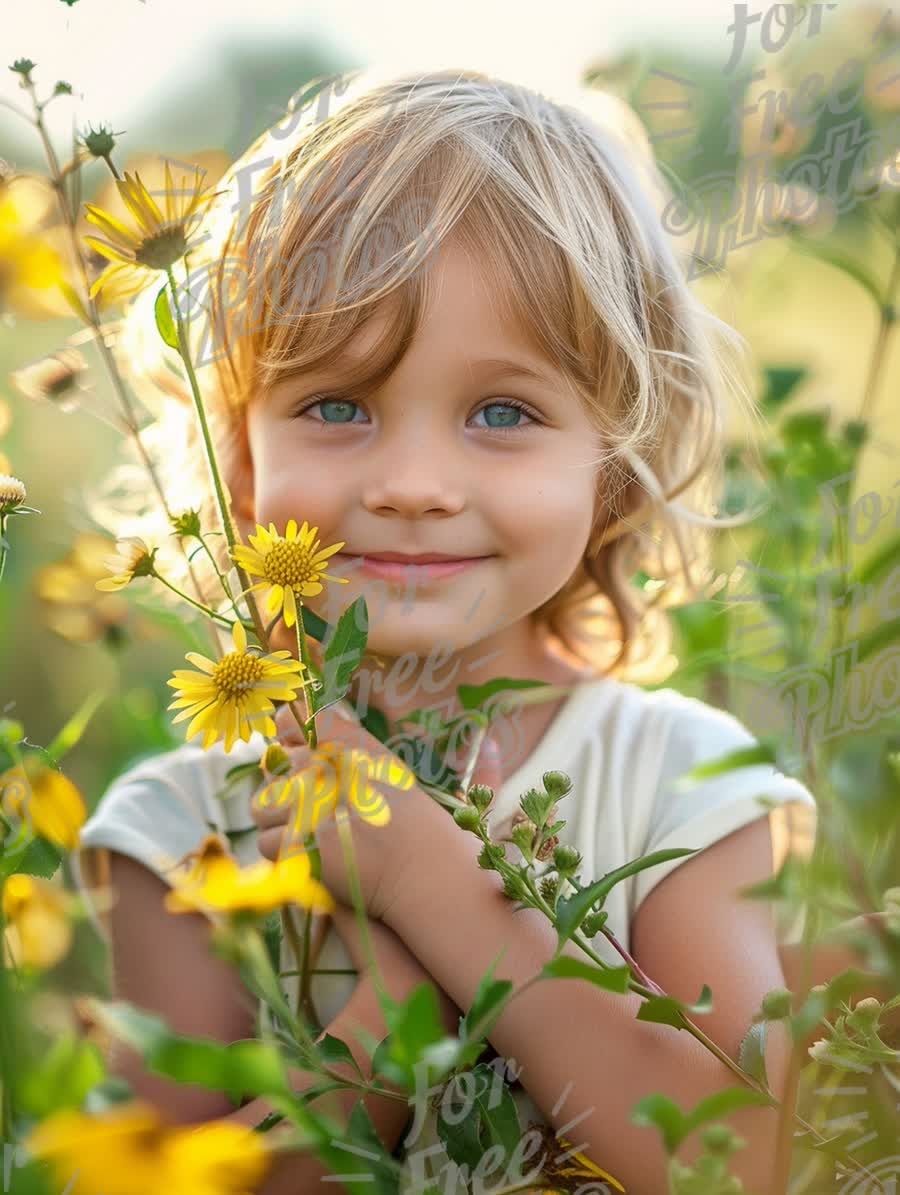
75, 71, 815, 1195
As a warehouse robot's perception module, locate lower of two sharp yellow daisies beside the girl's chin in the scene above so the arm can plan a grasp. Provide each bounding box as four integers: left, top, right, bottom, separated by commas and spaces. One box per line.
166, 623, 307, 753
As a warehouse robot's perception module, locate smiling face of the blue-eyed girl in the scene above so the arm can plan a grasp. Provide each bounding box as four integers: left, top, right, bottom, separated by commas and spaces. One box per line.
239, 233, 599, 674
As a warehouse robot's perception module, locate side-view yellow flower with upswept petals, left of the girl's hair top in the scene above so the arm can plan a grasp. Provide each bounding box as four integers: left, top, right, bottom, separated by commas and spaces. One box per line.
84, 163, 219, 298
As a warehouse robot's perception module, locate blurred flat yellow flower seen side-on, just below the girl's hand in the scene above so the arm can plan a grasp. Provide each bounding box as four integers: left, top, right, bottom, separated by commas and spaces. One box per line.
165, 834, 335, 914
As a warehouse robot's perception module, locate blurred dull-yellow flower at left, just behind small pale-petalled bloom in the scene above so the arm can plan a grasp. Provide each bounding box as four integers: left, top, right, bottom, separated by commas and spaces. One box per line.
35, 532, 131, 645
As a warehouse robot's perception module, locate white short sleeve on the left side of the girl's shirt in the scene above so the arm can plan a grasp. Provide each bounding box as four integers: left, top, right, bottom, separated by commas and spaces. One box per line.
69, 744, 226, 944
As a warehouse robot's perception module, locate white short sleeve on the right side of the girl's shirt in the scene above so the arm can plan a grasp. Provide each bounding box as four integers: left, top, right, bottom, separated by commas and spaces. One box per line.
631, 690, 816, 944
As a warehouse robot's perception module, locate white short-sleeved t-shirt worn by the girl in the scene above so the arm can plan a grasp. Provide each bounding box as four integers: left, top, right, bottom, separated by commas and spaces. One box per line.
72, 678, 816, 1169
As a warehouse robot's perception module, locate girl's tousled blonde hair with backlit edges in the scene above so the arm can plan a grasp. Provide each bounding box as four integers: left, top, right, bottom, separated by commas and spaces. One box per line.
99, 69, 758, 678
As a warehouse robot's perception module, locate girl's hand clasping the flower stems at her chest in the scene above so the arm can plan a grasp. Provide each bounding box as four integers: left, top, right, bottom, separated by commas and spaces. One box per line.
251, 705, 500, 920
